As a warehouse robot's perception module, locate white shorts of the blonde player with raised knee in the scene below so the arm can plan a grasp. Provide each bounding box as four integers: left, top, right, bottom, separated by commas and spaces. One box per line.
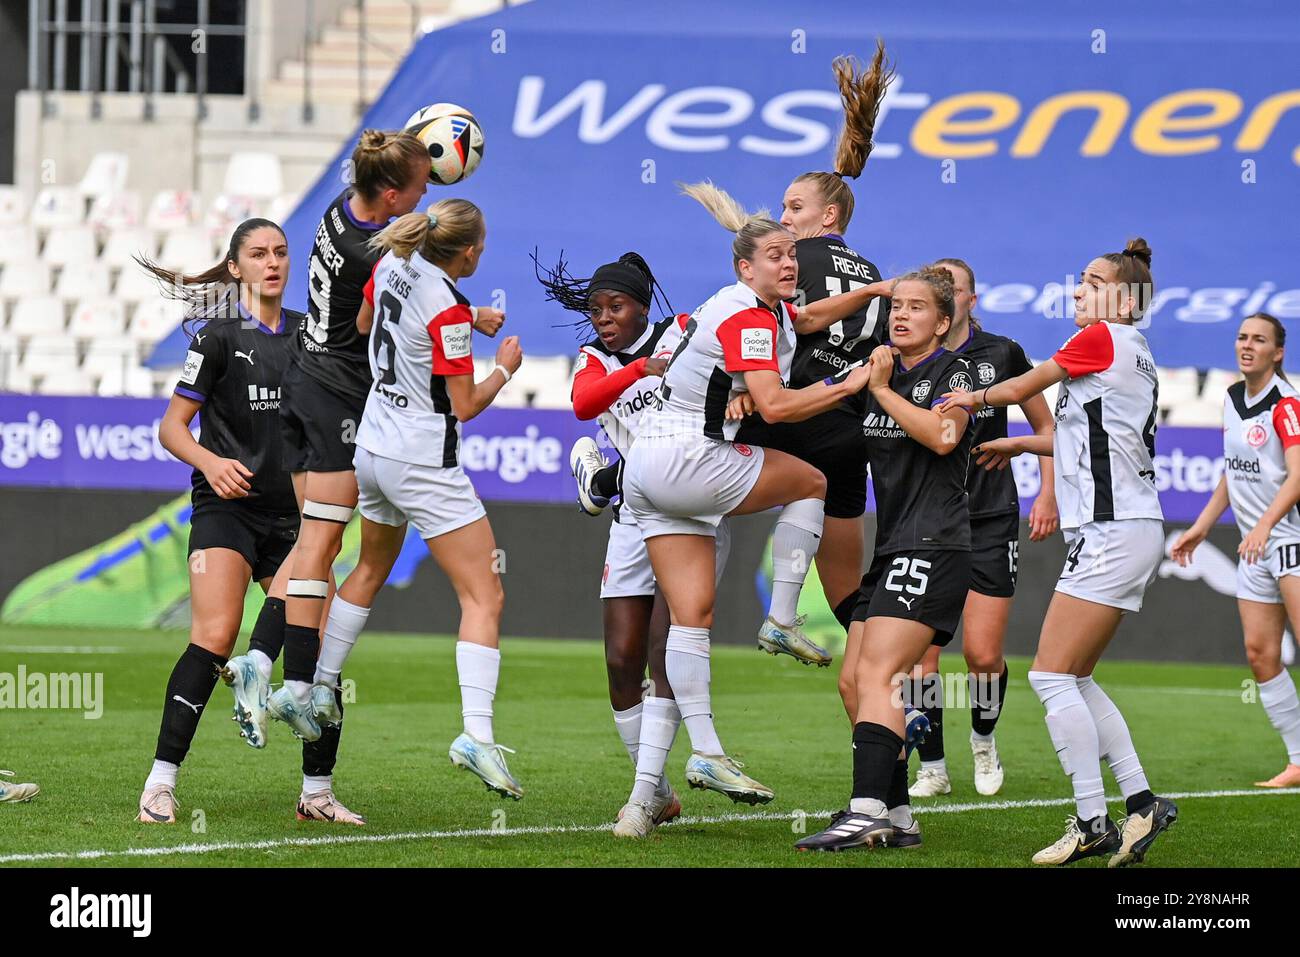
623, 436, 763, 538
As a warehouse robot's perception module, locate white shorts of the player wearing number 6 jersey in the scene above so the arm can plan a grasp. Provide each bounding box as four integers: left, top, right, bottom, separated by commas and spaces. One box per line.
352, 446, 488, 540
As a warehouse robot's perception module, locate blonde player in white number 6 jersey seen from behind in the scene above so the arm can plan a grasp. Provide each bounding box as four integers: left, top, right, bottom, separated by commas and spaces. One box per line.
305, 199, 524, 800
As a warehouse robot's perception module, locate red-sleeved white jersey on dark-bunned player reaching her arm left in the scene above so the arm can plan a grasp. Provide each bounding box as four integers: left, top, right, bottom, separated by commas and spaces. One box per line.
1052, 322, 1165, 528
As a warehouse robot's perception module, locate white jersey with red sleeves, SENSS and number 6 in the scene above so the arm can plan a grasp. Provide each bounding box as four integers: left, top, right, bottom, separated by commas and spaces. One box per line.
356, 252, 475, 468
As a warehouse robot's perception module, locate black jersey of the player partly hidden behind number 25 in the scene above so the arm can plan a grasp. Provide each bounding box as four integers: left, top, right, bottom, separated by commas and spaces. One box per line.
953, 326, 1034, 519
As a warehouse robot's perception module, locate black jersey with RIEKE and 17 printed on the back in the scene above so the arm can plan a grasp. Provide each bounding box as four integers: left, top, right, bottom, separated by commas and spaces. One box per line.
790, 235, 889, 415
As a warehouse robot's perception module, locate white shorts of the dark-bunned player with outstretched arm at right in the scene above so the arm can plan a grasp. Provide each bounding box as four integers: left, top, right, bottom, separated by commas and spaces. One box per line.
1056, 519, 1165, 611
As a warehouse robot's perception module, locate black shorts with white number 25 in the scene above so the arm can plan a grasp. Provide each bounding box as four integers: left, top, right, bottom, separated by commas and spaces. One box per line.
853, 551, 971, 646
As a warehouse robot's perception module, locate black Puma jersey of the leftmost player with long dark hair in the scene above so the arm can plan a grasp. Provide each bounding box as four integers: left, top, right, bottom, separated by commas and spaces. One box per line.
176, 306, 303, 514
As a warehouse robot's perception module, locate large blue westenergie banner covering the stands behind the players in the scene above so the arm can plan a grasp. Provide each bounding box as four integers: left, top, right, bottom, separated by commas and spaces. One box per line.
154, 0, 1300, 369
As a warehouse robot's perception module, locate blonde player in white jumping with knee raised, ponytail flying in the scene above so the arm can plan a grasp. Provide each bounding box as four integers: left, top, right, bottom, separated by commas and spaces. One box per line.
614, 183, 867, 837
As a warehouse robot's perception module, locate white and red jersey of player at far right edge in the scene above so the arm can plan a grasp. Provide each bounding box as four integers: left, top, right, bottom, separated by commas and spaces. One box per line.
1223, 374, 1300, 541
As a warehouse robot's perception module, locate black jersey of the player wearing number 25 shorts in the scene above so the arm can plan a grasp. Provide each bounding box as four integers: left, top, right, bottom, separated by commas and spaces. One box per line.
862, 348, 971, 555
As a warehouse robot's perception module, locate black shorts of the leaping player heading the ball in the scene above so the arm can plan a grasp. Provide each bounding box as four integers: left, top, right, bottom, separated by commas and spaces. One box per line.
280, 363, 365, 472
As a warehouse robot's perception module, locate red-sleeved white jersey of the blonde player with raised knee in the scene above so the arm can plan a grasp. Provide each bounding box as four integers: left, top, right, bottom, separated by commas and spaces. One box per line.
641, 276, 794, 442
